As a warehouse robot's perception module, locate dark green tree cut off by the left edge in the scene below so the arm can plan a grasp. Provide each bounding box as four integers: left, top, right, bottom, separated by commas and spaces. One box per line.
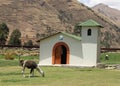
0, 23, 9, 45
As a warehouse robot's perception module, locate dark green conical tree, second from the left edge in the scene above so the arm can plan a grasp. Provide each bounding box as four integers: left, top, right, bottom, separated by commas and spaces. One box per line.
8, 29, 21, 46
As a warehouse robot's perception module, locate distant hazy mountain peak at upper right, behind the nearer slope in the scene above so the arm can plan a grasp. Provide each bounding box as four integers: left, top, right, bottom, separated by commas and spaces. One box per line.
93, 3, 120, 27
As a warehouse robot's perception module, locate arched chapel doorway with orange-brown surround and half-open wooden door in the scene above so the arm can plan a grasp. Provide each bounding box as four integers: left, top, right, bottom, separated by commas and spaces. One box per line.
52, 42, 70, 64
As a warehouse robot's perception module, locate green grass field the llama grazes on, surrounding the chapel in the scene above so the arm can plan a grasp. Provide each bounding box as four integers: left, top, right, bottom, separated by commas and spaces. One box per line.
0, 53, 120, 86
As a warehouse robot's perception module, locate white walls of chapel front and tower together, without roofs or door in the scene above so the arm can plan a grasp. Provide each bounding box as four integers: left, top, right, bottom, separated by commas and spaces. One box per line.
39, 27, 98, 66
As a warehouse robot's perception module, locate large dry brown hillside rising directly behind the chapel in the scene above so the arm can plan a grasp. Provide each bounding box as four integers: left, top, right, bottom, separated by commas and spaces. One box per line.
0, 0, 120, 47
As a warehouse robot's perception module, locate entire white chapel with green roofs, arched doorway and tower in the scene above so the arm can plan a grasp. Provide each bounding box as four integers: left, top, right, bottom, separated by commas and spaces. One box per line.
39, 19, 102, 67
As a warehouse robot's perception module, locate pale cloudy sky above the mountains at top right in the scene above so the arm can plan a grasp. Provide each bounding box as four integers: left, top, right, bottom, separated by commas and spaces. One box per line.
78, 0, 120, 10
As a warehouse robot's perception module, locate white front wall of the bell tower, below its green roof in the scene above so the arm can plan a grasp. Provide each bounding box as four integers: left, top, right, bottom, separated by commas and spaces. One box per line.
82, 27, 98, 66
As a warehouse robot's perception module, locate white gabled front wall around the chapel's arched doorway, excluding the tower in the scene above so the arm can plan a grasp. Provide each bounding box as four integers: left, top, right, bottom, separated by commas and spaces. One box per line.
39, 34, 83, 65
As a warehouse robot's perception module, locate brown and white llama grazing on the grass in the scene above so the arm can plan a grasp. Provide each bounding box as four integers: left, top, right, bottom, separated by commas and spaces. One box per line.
19, 57, 44, 78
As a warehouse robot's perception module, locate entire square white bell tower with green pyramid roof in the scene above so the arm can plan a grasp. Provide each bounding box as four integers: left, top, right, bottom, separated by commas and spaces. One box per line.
78, 19, 102, 66
